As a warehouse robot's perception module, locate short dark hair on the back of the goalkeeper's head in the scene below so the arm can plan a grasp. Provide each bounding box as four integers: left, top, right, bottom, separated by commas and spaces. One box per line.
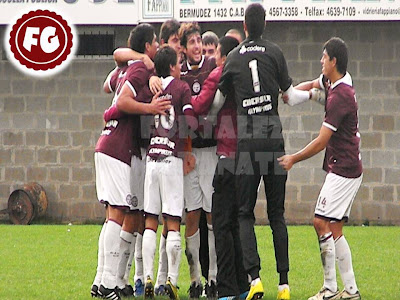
244, 3, 265, 39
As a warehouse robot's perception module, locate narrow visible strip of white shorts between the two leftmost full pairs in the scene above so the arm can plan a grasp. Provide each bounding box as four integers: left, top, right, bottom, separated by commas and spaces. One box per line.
130, 148, 146, 210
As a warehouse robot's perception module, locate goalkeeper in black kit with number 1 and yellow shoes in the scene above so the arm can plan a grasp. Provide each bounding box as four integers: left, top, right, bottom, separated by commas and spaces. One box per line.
219, 3, 308, 300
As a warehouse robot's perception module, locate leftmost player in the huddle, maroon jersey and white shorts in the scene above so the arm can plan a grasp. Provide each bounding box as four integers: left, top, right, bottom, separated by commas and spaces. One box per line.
95, 24, 169, 299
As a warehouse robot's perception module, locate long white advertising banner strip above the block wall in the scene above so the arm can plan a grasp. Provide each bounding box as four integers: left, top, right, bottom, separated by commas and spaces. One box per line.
0, 0, 400, 25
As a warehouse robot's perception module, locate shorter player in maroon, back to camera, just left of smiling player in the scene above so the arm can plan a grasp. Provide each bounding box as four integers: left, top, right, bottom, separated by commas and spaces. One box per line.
143, 46, 197, 299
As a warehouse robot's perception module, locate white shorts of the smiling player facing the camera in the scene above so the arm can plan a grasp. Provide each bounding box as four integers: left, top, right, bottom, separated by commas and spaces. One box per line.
184, 147, 218, 213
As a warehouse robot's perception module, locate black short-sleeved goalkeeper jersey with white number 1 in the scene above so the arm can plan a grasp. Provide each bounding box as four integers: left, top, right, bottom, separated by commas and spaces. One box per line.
218, 39, 292, 140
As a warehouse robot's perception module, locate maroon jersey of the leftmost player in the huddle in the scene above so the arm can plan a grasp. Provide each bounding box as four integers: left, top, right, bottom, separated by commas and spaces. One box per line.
95, 61, 150, 165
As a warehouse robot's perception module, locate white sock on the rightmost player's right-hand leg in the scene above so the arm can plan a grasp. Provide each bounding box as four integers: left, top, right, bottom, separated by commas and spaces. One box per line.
335, 235, 358, 294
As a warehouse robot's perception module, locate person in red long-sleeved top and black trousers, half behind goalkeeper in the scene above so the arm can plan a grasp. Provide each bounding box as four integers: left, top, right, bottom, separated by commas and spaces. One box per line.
192, 36, 249, 300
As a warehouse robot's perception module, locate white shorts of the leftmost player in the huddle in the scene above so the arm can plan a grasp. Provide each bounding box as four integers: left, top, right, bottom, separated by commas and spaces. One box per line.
94, 152, 133, 209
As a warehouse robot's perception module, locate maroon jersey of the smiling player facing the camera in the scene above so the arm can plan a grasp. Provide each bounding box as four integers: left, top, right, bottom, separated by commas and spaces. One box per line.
181, 55, 217, 148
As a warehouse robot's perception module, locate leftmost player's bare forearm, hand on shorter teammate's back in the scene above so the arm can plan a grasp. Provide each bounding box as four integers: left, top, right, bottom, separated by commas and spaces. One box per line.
116, 82, 171, 115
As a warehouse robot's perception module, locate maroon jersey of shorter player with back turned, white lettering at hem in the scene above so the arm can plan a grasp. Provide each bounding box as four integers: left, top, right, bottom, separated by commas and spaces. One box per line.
147, 76, 194, 160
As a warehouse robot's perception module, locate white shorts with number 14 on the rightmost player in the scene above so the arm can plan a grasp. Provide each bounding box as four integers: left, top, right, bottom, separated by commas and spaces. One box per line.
315, 173, 363, 221
